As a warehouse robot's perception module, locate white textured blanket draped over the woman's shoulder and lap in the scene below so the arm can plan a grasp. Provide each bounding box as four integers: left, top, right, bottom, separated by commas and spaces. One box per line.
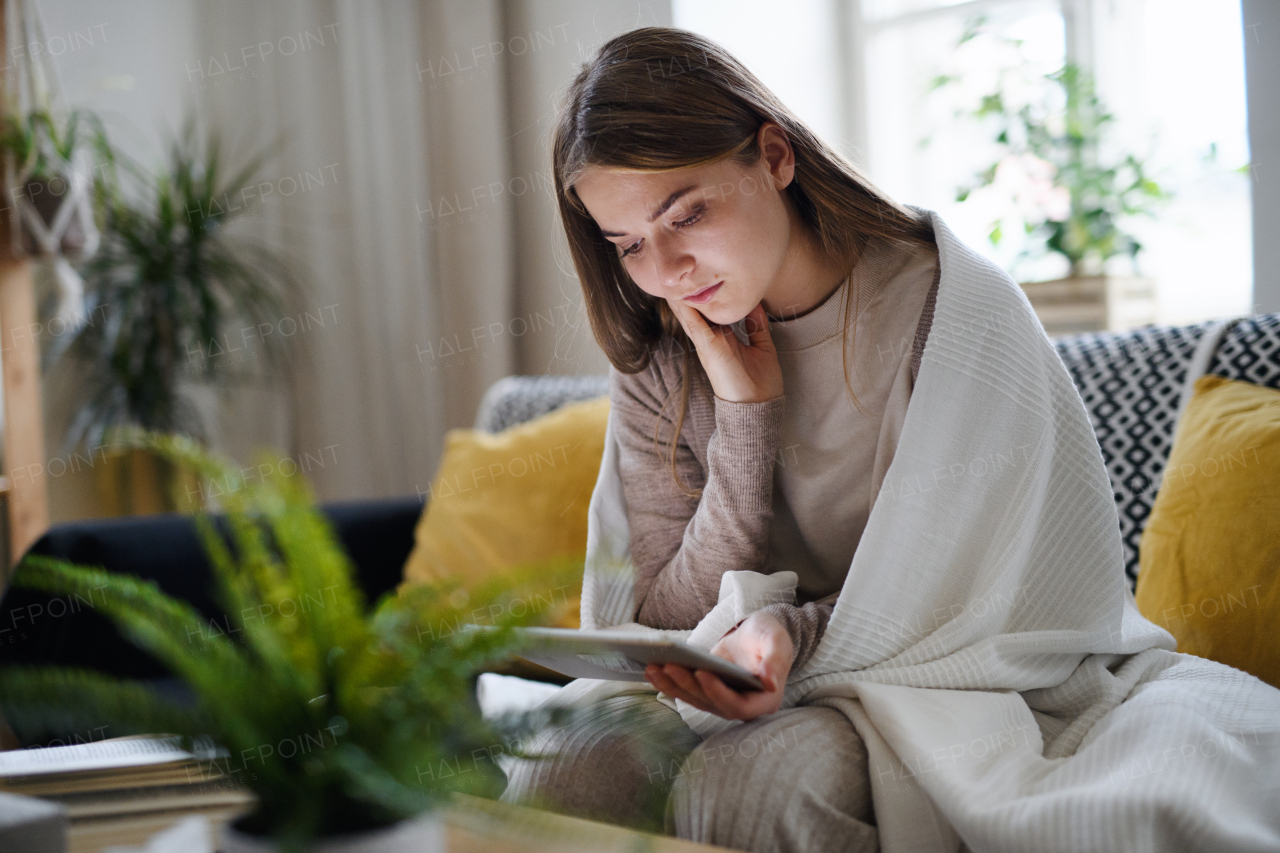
553, 202, 1280, 853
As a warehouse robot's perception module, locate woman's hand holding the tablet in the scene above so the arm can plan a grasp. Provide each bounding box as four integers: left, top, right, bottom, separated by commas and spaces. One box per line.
644, 612, 795, 720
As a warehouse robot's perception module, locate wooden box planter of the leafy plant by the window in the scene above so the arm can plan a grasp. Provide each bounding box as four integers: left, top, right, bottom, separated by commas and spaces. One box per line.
1021, 275, 1156, 337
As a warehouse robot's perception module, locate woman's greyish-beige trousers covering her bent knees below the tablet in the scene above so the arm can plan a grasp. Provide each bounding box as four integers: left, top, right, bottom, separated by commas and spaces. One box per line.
502, 693, 879, 853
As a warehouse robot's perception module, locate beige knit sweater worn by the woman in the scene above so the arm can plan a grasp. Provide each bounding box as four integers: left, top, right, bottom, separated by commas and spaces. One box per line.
609, 233, 940, 669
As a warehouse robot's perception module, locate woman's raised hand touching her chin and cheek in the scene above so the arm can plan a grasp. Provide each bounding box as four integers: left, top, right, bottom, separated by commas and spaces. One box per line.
667, 298, 782, 402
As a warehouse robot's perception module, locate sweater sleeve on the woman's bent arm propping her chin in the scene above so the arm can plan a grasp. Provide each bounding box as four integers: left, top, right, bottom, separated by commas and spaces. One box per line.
609, 364, 785, 629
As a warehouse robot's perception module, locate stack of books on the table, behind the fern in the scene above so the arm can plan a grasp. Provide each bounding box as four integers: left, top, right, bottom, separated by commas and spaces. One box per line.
0, 736, 255, 853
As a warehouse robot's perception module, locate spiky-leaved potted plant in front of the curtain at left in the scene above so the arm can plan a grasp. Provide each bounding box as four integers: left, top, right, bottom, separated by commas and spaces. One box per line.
46, 120, 301, 514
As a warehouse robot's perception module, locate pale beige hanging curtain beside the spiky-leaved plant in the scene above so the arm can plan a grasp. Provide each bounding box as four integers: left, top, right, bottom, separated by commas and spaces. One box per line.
188, 0, 516, 500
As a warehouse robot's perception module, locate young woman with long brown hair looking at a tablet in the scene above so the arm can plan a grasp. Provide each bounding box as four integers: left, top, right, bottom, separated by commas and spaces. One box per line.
504, 28, 938, 850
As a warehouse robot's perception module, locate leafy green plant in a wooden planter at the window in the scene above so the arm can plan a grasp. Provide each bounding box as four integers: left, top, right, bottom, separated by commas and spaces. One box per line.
929, 17, 1171, 334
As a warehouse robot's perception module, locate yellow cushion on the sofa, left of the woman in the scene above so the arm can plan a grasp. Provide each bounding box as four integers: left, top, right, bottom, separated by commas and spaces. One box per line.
401, 397, 609, 628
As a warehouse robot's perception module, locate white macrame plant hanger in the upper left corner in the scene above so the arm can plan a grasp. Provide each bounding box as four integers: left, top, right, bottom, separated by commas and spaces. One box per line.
4, 0, 99, 334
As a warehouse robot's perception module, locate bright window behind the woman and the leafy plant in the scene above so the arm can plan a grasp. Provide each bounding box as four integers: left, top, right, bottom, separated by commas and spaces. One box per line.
673, 0, 1253, 324
